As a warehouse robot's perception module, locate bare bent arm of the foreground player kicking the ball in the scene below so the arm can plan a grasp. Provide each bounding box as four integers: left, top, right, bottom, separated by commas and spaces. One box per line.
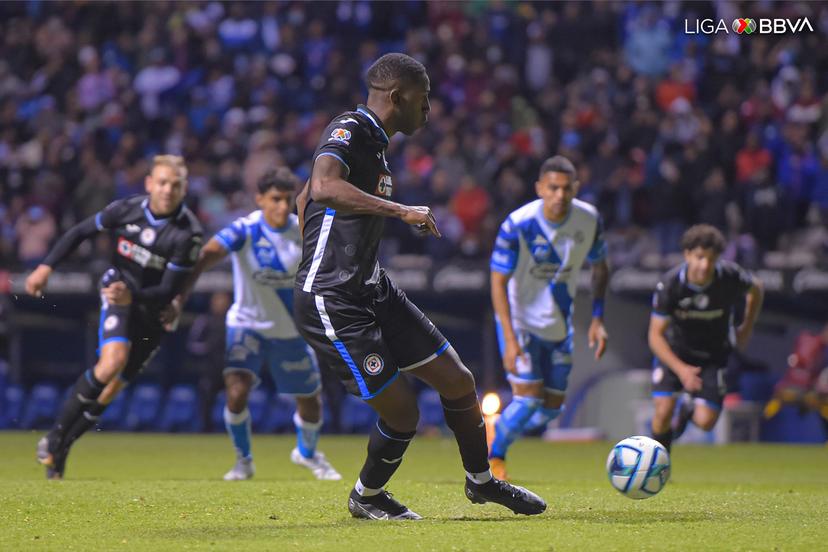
308, 155, 440, 238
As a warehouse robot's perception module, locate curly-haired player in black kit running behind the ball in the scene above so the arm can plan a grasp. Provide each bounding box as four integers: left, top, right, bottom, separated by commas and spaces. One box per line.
648, 224, 763, 451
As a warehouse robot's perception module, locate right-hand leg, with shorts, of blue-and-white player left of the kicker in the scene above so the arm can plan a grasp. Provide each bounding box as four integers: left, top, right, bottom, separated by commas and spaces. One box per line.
266, 338, 342, 481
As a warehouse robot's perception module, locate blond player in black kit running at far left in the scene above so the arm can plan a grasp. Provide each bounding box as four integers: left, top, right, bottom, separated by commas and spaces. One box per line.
26, 155, 202, 479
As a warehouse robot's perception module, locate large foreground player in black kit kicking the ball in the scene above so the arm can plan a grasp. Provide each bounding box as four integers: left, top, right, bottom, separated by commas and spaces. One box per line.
294, 54, 546, 520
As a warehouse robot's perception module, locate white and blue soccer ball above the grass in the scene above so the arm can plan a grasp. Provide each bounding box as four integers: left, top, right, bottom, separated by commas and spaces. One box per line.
607, 435, 670, 499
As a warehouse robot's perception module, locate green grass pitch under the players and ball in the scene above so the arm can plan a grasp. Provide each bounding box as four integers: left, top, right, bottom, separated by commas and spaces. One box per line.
0, 433, 828, 552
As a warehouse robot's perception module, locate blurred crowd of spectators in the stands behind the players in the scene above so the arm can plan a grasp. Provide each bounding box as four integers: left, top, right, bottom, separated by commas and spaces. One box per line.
0, 0, 828, 269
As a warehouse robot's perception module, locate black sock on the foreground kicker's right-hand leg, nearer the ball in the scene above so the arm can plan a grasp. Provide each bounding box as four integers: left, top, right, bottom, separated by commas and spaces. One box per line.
440, 393, 489, 473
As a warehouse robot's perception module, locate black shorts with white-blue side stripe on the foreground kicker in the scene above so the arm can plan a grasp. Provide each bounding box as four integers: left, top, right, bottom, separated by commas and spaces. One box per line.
294, 271, 449, 399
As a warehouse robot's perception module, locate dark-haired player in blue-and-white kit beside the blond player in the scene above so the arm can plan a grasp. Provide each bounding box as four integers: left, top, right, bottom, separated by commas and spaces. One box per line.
174, 167, 341, 481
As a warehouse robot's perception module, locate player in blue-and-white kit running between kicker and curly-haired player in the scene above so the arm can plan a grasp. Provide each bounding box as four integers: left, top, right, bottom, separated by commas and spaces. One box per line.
489, 155, 609, 479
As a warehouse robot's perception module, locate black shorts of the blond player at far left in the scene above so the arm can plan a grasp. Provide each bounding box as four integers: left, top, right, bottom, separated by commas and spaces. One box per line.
98, 297, 164, 383
